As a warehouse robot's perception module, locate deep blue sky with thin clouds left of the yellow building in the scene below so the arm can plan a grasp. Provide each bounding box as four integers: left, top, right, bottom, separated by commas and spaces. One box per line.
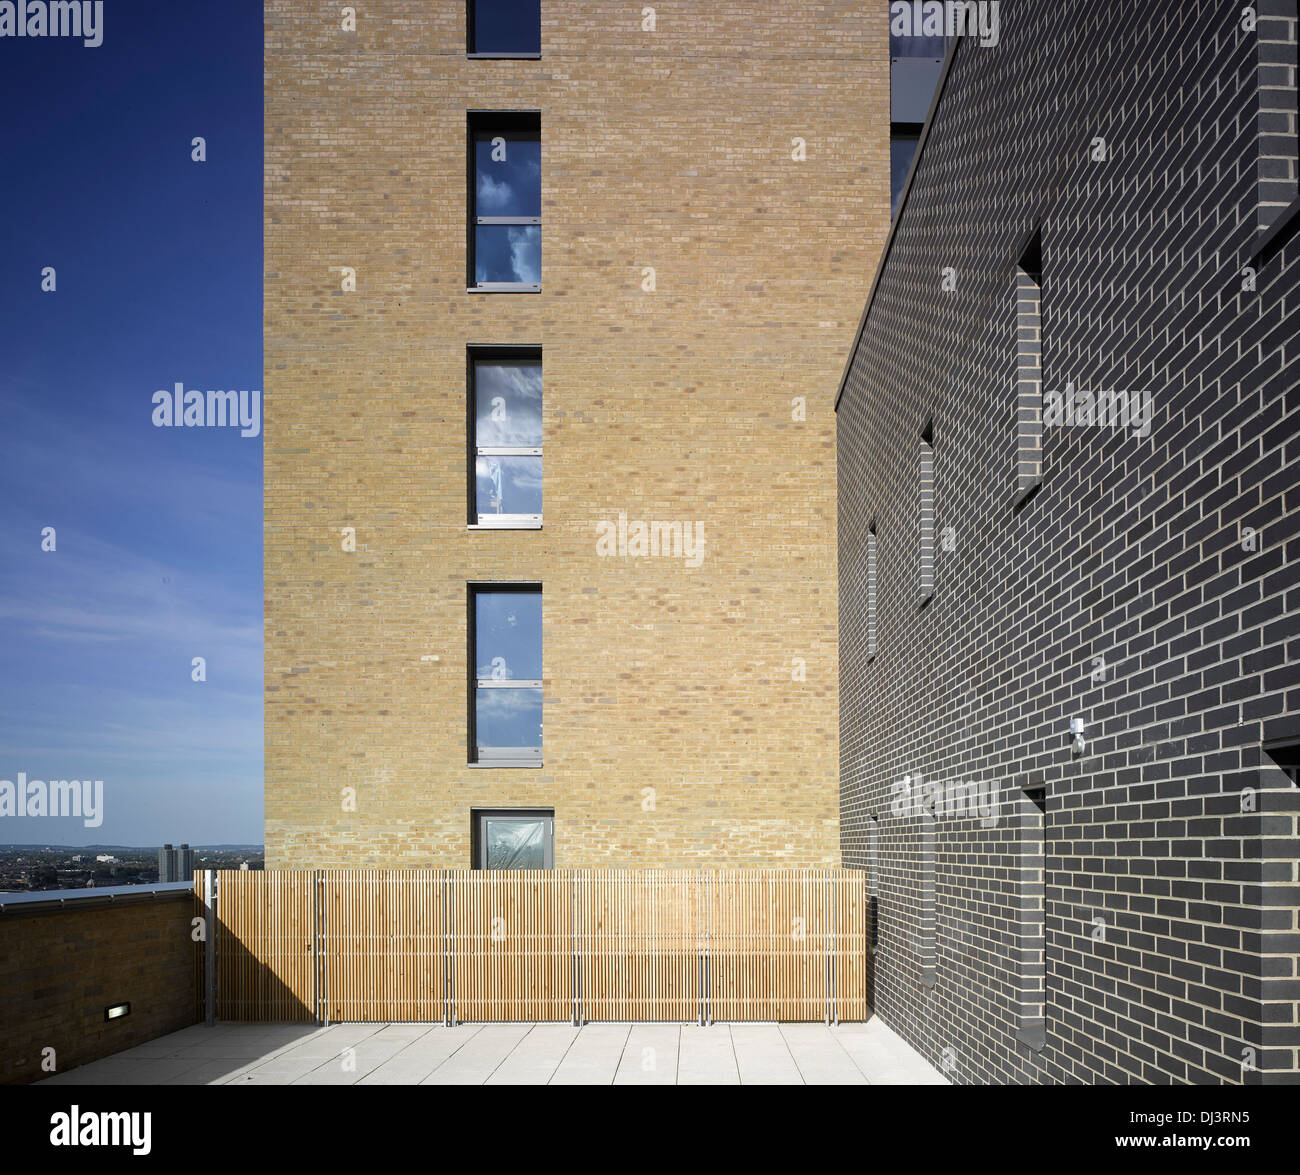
0, 0, 263, 845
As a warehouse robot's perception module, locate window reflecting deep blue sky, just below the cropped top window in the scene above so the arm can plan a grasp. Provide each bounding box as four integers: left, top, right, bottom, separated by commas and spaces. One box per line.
469, 113, 542, 291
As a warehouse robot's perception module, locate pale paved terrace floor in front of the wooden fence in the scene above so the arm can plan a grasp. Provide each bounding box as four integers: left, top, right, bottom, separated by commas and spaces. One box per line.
40, 1018, 948, 1085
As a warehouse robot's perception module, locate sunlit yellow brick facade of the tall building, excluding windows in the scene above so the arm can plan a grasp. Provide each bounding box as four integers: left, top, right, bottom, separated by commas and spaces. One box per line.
265, 0, 889, 867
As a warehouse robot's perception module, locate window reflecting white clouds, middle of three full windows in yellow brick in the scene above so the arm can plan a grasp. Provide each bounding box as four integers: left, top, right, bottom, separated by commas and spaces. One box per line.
469, 347, 542, 529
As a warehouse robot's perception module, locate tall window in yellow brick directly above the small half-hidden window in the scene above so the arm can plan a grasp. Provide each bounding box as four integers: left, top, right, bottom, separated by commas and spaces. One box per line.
469, 584, 542, 767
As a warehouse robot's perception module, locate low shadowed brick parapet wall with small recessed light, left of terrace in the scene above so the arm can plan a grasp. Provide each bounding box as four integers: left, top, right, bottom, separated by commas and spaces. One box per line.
0, 892, 202, 1085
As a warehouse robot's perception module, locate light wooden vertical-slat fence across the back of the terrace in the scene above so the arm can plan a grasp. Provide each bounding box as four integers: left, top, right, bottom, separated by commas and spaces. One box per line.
195, 868, 867, 1023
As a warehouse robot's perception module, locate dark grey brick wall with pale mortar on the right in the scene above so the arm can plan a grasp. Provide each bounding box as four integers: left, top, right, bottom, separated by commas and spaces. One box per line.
839, 0, 1300, 1084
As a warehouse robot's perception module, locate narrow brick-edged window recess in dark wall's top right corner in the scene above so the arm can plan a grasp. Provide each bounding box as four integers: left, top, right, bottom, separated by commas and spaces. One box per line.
1255, 0, 1300, 230
